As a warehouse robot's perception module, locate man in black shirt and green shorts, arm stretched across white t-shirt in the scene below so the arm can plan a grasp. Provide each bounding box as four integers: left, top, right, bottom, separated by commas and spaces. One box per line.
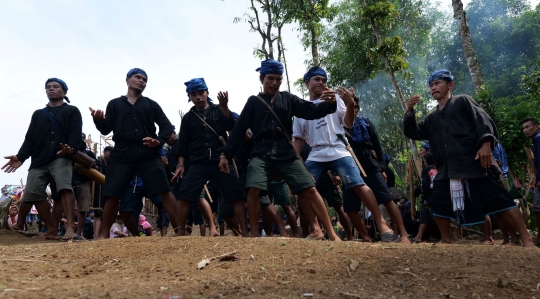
219, 59, 339, 241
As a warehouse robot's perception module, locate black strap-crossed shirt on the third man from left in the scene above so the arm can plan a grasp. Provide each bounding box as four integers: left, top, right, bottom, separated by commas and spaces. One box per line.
178, 102, 235, 163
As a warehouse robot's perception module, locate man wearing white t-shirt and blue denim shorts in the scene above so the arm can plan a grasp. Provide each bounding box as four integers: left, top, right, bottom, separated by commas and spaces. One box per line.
293, 67, 394, 241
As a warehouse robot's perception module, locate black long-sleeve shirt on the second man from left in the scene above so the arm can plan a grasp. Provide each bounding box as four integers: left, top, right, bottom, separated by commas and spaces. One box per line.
94, 96, 173, 162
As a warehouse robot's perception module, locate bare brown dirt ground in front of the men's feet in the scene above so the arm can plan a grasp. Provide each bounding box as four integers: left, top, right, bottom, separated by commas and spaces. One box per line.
0, 230, 540, 299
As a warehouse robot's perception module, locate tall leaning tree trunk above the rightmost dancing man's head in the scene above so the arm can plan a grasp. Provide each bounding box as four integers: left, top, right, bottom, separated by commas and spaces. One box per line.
452, 0, 484, 93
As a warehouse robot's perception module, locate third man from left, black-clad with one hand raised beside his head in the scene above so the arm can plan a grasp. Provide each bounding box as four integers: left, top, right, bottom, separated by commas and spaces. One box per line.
172, 78, 244, 236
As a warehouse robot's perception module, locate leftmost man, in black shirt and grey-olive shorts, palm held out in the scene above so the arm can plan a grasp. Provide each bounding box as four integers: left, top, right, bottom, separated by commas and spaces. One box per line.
2, 78, 82, 239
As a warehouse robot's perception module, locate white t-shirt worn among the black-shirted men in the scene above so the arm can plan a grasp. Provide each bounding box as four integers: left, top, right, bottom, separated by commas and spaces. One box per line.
293, 95, 351, 162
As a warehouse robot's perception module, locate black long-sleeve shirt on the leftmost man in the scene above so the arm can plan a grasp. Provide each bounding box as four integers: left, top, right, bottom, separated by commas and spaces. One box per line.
17, 103, 82, 169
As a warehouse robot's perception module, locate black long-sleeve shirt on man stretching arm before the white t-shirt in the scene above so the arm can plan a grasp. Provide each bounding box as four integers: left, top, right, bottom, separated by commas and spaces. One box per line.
223, 91, 336, 161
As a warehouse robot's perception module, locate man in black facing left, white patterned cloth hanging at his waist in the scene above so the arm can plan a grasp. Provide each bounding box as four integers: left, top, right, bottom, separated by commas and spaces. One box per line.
403, 70, 534, 247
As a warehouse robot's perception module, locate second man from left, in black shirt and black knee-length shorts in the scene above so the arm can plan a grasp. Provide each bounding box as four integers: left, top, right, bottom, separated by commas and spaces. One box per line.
90, 68, 179, 239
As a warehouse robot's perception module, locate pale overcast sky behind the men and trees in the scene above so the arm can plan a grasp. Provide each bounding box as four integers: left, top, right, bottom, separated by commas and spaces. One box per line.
0, 0, 538, 186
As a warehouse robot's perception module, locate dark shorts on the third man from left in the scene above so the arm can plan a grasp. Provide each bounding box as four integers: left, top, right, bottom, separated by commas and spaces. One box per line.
178, 161, 245, 202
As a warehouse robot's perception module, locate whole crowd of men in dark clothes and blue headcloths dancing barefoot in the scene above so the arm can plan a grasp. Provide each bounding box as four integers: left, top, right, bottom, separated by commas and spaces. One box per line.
2, 59, 540, 247
